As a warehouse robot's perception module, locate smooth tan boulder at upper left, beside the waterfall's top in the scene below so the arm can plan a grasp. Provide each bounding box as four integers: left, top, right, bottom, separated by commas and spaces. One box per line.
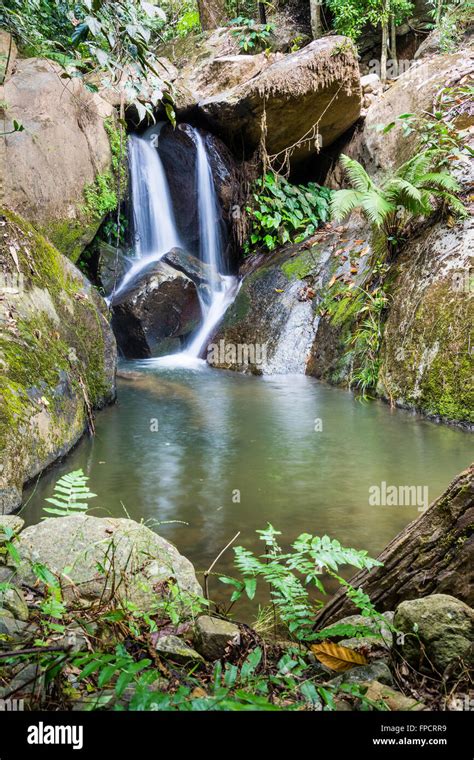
0, 53, 113, 261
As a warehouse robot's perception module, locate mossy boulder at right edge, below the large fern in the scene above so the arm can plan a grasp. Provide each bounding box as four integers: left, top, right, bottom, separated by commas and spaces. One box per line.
378, 211, 474, 426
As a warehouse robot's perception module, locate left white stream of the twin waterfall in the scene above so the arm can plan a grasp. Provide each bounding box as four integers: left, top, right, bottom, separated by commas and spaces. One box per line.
114, 124, 181, 298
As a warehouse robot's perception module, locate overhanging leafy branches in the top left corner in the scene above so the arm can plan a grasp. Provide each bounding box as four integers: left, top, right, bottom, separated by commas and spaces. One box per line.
0, 0, 174, 121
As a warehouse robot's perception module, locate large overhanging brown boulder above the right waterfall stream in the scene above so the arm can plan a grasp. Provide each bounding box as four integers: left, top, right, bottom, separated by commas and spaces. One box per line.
197, 36, 361, 163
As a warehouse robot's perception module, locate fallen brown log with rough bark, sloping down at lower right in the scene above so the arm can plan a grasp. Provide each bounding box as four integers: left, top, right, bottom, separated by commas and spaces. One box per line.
315, 465, 474, 629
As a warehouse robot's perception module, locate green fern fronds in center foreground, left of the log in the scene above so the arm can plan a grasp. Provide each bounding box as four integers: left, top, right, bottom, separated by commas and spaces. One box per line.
220, 524, 380, 641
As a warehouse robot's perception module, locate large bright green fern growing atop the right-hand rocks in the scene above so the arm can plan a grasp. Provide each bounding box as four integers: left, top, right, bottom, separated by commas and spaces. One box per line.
331, 149, 467, 258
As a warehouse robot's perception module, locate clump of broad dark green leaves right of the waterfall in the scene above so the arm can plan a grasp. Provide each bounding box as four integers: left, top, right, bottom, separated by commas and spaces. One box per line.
244, 174, 332, 253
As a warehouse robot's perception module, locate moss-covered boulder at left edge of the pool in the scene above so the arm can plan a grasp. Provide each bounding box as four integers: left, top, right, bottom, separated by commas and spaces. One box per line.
0, 210, 116, 513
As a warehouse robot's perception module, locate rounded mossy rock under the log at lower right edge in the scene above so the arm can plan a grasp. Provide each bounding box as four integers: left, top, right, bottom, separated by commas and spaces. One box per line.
394, 594, 474, 673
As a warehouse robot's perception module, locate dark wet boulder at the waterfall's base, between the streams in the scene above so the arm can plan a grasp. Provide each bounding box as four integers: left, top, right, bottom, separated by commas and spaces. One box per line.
112, 261, 201, 359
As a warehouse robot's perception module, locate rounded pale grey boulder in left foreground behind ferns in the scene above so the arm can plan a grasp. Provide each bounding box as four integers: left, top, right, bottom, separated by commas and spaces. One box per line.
16, 514, 202, 610
